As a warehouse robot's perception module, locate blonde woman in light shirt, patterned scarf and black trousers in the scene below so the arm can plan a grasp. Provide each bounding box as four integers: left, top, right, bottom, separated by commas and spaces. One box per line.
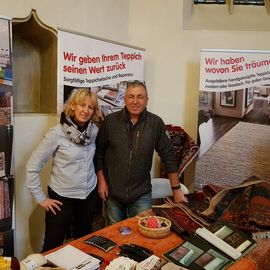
26, 88, 100, 252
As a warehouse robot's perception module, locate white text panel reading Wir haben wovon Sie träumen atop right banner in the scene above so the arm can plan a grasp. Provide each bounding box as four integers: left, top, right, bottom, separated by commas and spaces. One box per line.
200, 49, 270, 92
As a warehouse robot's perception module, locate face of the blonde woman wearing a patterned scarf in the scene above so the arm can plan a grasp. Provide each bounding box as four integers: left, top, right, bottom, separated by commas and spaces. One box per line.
71, 97, 94, 126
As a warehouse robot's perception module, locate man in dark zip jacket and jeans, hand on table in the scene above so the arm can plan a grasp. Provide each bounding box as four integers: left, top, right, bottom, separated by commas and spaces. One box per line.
95, 81, 187, 224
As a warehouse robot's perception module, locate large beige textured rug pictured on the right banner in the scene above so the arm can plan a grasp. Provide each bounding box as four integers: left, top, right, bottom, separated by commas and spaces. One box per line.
195, 122, 270, 190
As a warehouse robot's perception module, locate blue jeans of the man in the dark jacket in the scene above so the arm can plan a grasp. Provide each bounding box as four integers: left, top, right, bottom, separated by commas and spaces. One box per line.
106, 192, 152, 225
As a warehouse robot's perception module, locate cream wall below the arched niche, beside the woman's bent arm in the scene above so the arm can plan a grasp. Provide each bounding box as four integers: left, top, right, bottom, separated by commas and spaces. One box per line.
14, 114, 57, 258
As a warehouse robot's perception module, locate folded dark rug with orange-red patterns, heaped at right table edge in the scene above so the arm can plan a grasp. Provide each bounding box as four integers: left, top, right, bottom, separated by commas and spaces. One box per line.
201, 179, 270, 232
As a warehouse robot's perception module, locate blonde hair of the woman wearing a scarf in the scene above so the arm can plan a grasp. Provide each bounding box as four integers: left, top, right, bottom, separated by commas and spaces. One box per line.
64, 88, 102, 123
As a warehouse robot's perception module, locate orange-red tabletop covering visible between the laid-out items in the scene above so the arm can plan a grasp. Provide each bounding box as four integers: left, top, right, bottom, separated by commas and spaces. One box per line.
44, 216, 257, 270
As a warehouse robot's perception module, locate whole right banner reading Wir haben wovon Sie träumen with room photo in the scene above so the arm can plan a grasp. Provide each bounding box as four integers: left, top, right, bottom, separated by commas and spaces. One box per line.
195, 50, 270, 189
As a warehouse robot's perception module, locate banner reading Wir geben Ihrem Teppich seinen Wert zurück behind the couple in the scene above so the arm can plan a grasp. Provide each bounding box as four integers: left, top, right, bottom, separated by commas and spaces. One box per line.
57, 29, 144, 116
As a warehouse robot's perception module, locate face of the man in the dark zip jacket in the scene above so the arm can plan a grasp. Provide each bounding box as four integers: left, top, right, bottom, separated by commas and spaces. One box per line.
125, 86, 148, 117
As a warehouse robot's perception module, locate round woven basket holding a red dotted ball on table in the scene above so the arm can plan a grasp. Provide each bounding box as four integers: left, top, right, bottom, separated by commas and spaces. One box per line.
138, 216, 172, 238
